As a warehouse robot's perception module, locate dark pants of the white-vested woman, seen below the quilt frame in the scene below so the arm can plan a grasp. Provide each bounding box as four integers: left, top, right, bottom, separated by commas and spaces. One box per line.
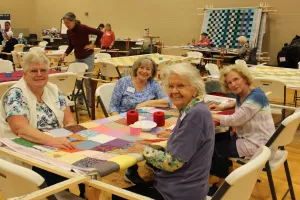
32, 167, 85, 198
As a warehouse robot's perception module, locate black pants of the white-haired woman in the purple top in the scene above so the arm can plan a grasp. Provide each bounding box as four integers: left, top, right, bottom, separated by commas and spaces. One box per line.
112, 181, 164, 200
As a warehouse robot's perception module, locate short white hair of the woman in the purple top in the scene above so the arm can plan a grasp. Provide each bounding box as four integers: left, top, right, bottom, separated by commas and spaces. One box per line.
162, 63, 205, 96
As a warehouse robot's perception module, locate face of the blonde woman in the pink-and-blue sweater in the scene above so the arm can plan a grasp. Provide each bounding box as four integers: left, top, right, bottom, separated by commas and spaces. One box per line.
225, 71, 249, 95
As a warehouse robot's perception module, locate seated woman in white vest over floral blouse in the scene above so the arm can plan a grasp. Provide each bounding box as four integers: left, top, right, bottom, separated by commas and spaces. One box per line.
0, 51, 75, 149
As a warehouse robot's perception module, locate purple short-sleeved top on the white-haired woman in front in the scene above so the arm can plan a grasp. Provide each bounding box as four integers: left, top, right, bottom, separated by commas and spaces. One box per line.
154, 102, 215, 200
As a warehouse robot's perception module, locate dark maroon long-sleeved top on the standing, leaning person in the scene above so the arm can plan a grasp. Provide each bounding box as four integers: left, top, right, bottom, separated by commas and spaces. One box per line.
65, 24, 103, 59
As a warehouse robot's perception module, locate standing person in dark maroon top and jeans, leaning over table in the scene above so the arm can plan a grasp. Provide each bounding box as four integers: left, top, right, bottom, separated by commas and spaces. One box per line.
61, 12, 103, 114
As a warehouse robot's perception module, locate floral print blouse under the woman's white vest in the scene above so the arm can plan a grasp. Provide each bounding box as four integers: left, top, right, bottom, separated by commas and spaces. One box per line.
3, 88, 67, 131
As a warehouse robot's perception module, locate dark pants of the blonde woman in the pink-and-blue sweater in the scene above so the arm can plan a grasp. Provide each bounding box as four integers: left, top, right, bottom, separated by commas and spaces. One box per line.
210, 132, 239, 178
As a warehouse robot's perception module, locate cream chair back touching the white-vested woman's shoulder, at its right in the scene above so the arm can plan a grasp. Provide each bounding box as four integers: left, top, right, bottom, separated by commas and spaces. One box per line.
49, 72, 77, 96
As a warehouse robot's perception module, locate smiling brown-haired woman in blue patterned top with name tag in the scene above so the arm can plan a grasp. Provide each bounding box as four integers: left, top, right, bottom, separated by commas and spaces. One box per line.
110, 56, 171, 115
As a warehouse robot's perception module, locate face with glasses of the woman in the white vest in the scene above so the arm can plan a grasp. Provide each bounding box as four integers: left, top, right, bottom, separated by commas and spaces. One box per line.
24, 63, 48, 90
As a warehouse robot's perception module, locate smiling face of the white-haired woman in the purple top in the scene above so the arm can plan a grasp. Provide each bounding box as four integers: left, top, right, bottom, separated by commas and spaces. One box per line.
167, 73, 198, 110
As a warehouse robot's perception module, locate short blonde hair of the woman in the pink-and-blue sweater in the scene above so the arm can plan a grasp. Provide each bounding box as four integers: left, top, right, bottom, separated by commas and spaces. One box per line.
220, 65, 253, 92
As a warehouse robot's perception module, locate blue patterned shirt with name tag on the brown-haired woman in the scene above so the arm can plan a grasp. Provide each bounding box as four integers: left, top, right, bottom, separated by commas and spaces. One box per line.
109, 76, 171, 113
